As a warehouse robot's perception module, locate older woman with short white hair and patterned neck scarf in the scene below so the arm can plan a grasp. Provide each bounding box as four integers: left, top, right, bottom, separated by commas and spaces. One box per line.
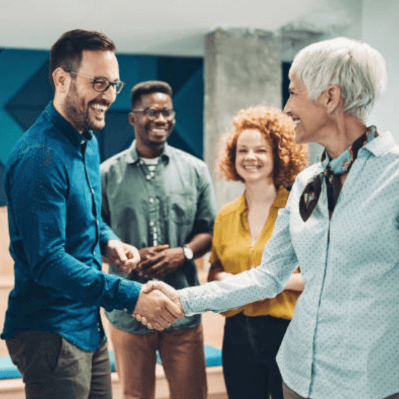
140, 38, 399, 399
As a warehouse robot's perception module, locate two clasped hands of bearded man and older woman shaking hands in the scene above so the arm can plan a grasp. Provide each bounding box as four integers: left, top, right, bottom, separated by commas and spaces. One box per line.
132, 281, 184, 331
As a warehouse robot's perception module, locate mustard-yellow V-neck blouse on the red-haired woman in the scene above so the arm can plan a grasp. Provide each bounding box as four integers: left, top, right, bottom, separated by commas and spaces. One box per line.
208, 188, 300, 320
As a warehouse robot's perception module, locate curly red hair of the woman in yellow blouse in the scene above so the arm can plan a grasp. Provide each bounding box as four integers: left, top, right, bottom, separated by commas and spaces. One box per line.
217, 106, 308, 188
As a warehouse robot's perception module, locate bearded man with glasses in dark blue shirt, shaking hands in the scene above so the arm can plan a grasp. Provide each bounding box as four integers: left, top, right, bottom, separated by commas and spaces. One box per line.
2, 30, 181, 399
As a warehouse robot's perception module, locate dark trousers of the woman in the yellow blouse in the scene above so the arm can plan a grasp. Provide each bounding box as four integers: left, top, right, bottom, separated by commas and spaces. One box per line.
222, 314, 289, 399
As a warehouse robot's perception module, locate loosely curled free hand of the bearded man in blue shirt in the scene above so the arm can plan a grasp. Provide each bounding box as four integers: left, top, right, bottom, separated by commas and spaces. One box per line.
103, 240, 140, 273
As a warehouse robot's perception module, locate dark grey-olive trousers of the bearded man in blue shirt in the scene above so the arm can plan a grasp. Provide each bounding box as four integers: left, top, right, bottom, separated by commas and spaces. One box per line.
6, 331, 112, 399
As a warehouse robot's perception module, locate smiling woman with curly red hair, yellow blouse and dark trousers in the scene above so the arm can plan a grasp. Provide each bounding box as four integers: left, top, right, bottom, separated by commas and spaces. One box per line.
208, 106, 307, 399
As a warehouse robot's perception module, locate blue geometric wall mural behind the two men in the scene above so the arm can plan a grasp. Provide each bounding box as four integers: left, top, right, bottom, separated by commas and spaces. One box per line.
0, 49, 204, 206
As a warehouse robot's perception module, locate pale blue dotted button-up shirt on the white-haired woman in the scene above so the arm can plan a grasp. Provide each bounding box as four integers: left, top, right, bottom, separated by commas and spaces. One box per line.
180, 133, 399, 399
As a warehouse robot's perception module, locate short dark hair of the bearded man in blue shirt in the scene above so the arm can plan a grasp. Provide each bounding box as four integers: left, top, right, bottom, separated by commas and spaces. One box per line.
49, 29, 115, 86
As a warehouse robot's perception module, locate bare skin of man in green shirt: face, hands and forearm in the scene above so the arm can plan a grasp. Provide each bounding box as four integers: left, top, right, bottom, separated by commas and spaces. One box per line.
129, 93, 212, 279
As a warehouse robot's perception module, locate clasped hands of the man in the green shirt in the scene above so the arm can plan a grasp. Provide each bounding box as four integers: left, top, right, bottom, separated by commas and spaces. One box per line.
137, 245, 185, 278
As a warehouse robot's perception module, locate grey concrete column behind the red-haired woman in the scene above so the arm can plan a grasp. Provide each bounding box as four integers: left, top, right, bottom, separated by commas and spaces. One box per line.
204, 28, 282, 208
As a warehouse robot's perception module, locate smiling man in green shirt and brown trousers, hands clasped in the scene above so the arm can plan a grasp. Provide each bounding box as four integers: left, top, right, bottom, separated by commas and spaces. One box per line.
101, 81, 216, 399
